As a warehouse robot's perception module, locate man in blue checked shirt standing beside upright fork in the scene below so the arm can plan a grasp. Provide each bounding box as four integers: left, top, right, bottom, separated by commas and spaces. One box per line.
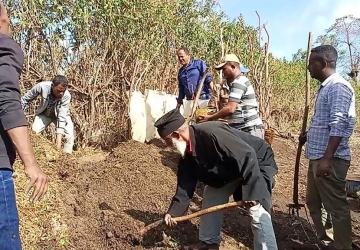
299, 45, 355, 250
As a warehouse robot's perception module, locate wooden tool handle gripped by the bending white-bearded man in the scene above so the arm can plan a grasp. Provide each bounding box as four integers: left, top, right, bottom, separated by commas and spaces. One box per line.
140, 201, 244, 236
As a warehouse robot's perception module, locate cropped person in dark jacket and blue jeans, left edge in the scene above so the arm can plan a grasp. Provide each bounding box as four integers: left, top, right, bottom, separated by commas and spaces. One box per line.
0, 2, 48, 250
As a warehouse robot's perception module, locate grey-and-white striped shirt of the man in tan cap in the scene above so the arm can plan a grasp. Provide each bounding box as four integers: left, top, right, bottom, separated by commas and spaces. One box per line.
228, 75, 263, 129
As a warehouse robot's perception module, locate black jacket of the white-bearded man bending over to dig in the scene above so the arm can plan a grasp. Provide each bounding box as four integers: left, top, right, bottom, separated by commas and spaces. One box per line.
168, 121, 278, 217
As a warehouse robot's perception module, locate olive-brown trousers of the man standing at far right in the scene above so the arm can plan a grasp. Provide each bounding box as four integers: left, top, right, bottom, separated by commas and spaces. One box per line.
306, 158, 352, 250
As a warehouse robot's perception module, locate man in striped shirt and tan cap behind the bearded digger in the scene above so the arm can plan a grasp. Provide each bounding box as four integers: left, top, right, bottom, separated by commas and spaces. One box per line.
200, 54, 264, 139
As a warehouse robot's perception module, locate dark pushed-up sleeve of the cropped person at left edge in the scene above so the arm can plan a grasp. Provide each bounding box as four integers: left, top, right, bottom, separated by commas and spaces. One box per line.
0, 35, 28, 130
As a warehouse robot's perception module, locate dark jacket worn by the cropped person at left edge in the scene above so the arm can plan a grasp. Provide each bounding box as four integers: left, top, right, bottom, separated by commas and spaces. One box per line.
0, 34, 28, 169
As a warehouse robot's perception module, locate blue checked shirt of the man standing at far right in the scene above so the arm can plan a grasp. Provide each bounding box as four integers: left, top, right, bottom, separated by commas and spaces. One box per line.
305, 73, 355, 160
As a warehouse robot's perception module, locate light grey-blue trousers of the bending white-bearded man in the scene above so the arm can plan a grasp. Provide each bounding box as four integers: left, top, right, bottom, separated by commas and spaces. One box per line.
199, 180, 278, 250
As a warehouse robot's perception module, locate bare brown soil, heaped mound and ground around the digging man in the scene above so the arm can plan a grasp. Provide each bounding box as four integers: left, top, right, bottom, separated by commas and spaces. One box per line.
14, 132, 360, 250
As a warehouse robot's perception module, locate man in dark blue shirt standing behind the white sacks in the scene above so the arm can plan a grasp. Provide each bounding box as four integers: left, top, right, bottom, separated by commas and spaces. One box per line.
176, 47, 215, 109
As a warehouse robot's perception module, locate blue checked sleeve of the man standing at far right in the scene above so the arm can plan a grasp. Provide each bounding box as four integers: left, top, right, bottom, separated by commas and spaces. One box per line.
328, 83, 354, 137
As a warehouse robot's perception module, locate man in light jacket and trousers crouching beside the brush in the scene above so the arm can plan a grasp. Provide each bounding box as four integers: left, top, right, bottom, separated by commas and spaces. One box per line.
21, 76, 74, 154
